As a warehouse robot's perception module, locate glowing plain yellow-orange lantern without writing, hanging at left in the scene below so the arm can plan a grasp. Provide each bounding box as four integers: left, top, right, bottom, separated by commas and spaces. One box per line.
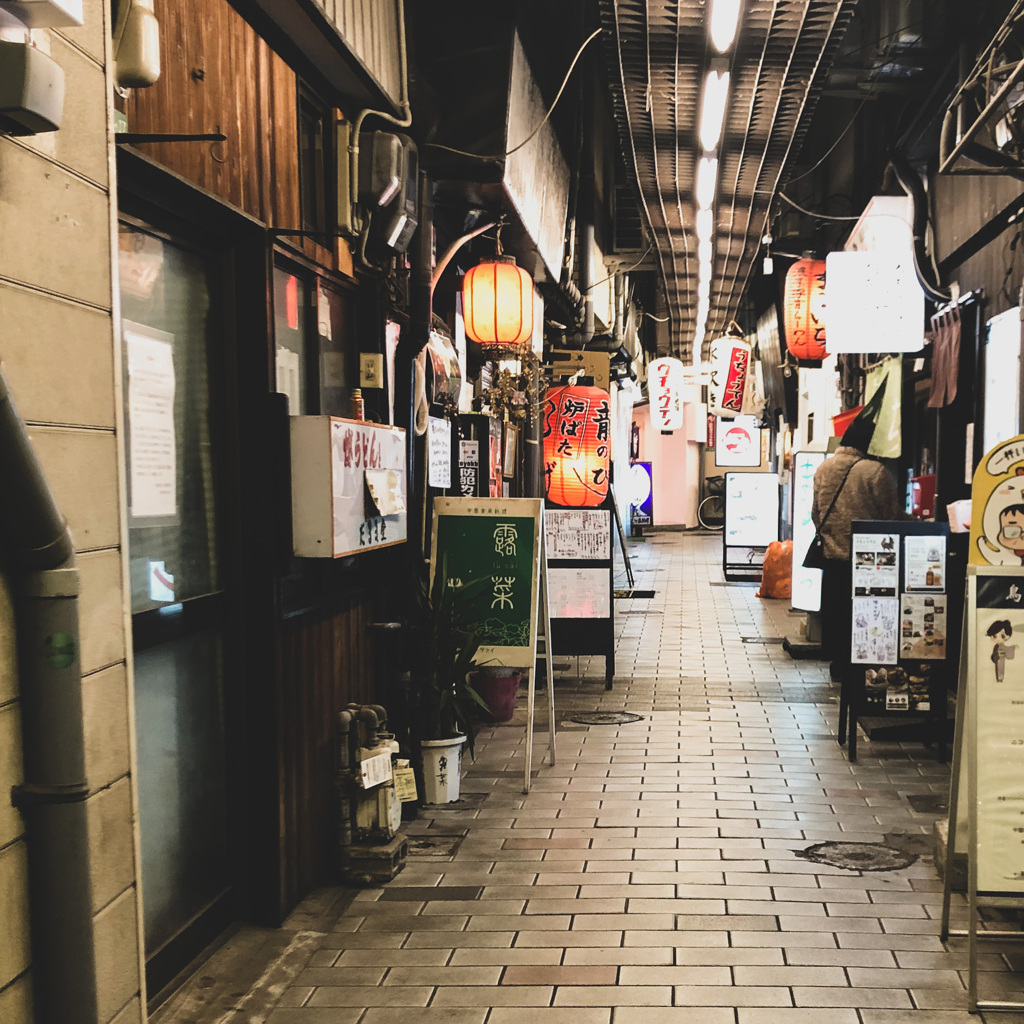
462, 256, 534, 345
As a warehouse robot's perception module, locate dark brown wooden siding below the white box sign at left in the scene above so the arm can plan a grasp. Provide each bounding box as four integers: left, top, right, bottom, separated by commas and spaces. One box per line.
279, 600, 375, 910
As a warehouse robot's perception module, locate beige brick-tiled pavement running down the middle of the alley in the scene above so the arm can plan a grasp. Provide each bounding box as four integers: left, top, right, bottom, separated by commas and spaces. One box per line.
161, 534, 1024, 1024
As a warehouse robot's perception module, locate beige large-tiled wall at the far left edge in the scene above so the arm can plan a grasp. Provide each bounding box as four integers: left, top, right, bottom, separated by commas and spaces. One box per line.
0, 0, 144, 1024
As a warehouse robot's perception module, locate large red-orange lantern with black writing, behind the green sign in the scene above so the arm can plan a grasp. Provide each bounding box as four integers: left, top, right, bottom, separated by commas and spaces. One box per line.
544, 385, 611, 508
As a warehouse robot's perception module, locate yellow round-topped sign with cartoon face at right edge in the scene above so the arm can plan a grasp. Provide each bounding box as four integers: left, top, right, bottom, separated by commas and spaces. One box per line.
971, 434, 1024, 565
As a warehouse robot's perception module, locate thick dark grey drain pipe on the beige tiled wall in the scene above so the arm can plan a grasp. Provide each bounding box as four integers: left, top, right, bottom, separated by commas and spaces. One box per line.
0, 370, 97, 1024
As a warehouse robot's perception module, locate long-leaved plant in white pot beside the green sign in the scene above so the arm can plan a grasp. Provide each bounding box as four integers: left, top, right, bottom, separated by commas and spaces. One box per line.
412, 562, 486, 804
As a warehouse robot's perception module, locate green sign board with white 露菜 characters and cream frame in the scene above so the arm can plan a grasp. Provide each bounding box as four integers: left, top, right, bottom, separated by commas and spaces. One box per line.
430, 498, 543, 668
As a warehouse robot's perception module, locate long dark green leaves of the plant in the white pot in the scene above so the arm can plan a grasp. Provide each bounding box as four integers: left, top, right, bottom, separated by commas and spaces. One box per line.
413, 560, 487, 757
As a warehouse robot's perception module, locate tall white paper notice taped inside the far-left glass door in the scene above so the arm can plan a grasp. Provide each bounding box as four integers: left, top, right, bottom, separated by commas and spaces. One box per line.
124, 322, 178, 518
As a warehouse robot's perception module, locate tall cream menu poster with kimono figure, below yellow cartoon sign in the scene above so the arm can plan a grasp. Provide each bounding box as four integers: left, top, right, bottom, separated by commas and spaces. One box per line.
973, 575, 1024, 893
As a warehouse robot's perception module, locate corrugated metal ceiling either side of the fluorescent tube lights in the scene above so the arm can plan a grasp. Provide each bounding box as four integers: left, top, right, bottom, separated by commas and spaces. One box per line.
599, 0, 857, 361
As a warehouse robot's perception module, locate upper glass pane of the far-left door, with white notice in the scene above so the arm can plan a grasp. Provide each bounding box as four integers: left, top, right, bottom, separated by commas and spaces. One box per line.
120, 224, 223, 612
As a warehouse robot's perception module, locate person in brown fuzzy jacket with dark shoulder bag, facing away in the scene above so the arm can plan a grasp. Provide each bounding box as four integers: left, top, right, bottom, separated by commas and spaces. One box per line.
811, 378, 901, 680
